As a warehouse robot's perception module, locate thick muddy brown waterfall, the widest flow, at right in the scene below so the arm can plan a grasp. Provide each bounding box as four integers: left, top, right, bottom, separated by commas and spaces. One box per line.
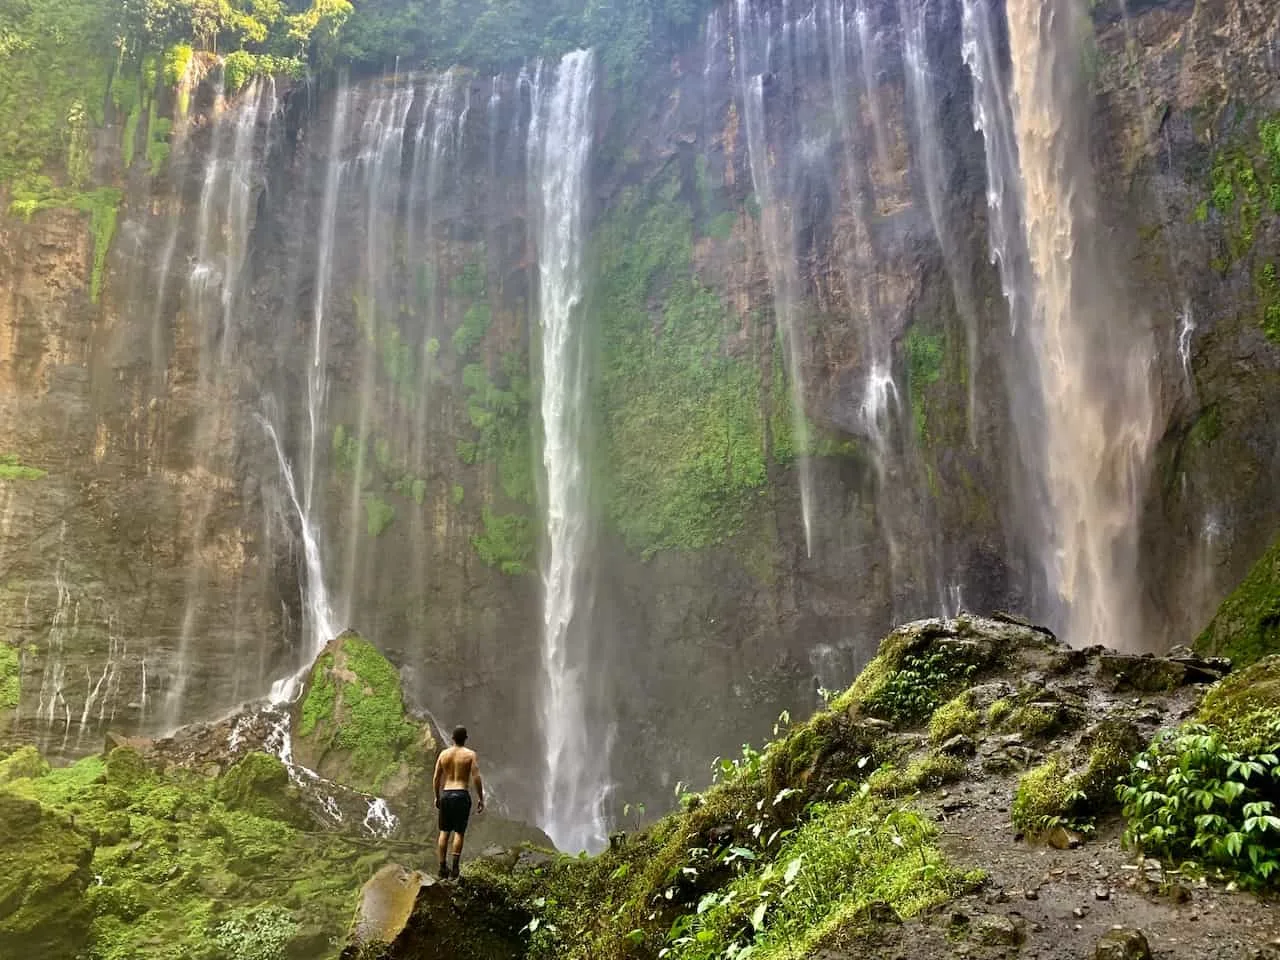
1007, 0, 1155, 649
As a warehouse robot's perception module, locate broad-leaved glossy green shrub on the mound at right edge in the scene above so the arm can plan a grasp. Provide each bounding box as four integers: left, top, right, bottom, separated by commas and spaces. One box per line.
1117, 716, 1280, 886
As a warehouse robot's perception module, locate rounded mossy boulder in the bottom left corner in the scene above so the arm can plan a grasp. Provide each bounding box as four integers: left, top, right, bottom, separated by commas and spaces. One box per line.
0, 791, 93, 960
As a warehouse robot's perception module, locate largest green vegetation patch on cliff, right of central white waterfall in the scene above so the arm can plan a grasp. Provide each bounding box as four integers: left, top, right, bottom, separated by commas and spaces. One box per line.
591, 179, 762, 554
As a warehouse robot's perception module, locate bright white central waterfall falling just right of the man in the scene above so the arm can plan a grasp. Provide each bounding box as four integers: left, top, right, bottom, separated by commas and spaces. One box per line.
529, 50, 607, 851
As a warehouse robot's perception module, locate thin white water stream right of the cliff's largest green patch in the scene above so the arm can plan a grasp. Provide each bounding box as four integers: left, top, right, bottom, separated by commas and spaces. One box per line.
735, 0, 814, 557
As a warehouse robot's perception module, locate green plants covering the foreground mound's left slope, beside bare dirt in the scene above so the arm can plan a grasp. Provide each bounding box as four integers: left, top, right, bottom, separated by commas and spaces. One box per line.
502, 686, 980, 960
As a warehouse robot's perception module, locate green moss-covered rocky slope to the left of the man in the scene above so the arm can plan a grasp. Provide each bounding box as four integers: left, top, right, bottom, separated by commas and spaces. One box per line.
0, 748, 387, 960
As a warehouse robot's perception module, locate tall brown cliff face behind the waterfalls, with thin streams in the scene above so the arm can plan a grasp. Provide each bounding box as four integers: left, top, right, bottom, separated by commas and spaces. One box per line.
0, 0, 1280, 829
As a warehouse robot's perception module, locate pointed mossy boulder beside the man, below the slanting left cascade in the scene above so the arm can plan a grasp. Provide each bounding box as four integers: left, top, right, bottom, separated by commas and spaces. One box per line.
293, 631, 435, 799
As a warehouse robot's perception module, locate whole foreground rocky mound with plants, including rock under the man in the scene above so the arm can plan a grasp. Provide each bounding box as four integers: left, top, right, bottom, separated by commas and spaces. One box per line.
347, 617, 1280, 960
